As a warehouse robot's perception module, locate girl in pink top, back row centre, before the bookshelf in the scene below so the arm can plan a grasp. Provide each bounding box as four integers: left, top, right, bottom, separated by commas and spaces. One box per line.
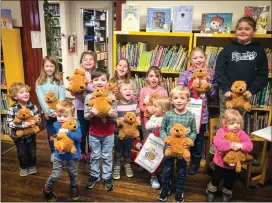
139, 66, 168, 138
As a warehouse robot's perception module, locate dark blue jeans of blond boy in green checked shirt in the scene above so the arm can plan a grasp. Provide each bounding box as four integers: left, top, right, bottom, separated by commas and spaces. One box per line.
162, 157, 187, 193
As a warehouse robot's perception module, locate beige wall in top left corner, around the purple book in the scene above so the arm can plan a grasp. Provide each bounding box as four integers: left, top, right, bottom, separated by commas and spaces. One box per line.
1, 1, 23, 27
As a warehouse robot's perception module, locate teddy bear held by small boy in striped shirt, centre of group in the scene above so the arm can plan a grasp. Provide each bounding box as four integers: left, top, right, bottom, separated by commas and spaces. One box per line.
117, 112, 141, 140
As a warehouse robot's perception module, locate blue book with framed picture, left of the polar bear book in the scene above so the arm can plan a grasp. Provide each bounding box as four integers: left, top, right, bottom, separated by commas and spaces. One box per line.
146, 8, 171, 32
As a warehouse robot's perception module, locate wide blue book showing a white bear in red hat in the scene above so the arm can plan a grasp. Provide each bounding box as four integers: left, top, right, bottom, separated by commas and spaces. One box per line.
201, 13, 232, 34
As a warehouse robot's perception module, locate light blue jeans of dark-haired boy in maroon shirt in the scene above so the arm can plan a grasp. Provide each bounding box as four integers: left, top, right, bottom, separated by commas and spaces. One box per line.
89, 134, 114, 180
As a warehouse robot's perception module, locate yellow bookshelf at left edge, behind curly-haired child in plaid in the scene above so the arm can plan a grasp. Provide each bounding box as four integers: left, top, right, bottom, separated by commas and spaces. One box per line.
1, 28, 24, 141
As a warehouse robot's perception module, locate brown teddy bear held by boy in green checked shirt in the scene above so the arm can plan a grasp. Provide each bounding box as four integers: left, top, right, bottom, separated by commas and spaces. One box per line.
164, 123, 194, 161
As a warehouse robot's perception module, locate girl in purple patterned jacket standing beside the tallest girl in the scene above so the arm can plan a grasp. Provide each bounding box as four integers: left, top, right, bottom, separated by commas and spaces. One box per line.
177, 47, 216, 175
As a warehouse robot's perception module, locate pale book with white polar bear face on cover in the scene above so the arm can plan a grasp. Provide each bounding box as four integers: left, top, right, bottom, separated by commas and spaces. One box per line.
173, 6, 194, 32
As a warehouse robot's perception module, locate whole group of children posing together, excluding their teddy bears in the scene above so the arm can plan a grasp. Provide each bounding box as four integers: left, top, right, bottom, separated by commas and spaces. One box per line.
7, 17, 268, 202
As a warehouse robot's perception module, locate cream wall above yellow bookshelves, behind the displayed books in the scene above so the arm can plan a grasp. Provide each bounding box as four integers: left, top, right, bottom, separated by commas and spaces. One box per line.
127, 1, 272, 30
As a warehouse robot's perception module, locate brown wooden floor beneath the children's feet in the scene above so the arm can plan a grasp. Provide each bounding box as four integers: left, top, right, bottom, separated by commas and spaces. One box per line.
1, 132, 272, 202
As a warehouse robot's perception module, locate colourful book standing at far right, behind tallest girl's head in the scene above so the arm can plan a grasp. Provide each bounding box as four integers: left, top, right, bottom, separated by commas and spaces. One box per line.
245, 6, 270, 34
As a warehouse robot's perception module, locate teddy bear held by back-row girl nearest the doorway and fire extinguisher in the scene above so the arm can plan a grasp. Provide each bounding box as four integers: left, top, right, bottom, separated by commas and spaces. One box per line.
66, 69, 88, 93
